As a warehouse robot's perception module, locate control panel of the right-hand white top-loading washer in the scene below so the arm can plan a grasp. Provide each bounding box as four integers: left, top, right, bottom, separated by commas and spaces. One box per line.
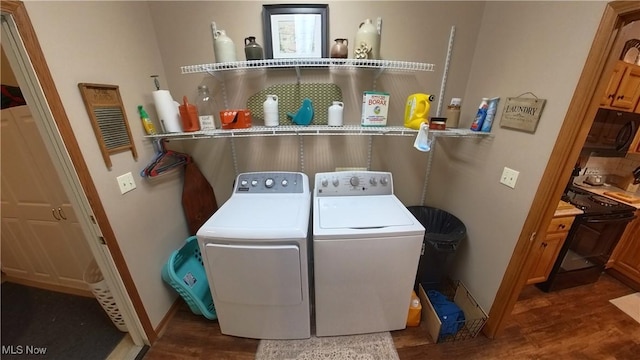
314, 171, 393, 196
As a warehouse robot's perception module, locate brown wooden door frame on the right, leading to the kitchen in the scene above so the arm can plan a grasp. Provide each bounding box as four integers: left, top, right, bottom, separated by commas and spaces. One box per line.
483, 1, 640, 338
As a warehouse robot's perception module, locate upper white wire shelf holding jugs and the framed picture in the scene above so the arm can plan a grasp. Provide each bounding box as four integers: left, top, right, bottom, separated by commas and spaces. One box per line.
180, 58, 434, 74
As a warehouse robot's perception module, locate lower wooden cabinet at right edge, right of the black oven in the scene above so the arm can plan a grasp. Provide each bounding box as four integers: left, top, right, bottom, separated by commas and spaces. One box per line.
608, 210, 640, 290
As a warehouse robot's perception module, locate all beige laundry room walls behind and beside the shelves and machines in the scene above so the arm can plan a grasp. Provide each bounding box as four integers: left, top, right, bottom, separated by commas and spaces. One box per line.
18, 1, 605, 325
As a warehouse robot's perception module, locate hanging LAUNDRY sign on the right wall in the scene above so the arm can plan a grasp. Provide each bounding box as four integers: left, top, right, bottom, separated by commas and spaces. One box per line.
500, 93, 547, 133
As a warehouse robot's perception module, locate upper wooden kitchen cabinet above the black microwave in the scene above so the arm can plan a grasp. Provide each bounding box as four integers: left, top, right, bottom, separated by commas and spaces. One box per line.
600, 61, 640, 112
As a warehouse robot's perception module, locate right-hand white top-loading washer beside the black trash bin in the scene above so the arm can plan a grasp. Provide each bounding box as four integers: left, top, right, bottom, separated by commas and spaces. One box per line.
313, 171, 425, 336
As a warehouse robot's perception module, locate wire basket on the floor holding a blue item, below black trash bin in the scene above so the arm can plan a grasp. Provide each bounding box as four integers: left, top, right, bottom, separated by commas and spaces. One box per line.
419, 281, 488, 343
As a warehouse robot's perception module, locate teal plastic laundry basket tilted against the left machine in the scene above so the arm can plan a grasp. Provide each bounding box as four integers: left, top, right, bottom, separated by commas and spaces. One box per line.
162, 236, 218, 320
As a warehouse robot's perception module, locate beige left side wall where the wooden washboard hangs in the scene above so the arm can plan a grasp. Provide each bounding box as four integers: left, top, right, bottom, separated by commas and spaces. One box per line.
25, 1, 187, 327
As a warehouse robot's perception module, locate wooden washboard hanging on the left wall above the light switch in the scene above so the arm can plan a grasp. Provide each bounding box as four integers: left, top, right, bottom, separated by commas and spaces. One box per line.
78, 83, 138, 169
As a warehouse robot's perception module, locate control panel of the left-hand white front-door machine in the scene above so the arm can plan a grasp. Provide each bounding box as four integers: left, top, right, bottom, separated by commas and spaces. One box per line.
235, 171, 305, 194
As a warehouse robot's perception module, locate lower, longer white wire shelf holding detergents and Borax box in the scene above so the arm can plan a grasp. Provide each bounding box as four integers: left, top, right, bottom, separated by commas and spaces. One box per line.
145, 125, 493, 140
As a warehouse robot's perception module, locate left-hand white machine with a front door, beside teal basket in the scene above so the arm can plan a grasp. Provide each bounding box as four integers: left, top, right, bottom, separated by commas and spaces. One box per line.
196, 172, 311, 339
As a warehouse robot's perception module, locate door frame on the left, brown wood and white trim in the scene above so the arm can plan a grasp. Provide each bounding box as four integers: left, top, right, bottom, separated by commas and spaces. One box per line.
0, 0, 158, 345
